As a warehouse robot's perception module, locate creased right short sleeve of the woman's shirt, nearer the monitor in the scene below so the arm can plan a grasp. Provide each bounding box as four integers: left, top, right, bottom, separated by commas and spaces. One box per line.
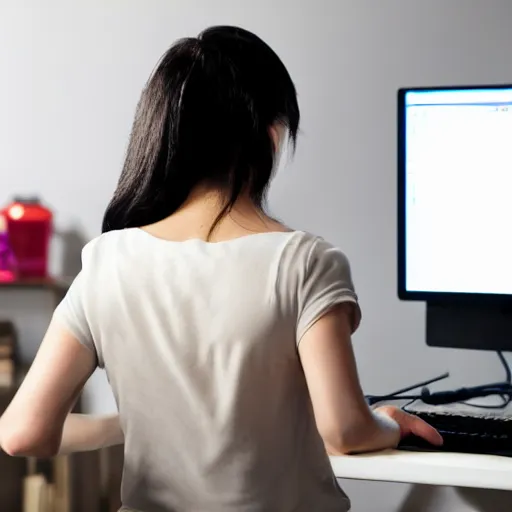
297, 238, 361, 341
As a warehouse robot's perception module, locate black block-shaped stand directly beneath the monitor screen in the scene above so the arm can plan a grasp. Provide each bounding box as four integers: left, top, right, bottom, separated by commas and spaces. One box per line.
426, 301, 512, 352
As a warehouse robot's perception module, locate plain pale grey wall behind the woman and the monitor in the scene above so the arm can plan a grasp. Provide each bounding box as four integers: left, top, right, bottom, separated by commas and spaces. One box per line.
0, 0, 512, 512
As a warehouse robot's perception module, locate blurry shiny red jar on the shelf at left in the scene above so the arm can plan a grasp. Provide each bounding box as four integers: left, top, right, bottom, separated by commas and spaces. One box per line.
2, 198, 53, 279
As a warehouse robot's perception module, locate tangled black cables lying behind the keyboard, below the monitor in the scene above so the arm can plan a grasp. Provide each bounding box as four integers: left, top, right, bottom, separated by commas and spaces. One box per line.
366, 352, 512, 409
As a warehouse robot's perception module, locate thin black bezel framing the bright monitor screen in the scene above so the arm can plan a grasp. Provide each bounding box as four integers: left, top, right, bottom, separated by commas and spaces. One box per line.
397, 83, 512, 306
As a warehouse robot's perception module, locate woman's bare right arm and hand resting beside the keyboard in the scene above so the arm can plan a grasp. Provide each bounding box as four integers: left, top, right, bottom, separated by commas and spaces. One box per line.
299, 304, 442, 455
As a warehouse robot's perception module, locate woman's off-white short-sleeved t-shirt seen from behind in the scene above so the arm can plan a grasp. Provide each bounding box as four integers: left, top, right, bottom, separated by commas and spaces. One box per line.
55, 229, 360, 512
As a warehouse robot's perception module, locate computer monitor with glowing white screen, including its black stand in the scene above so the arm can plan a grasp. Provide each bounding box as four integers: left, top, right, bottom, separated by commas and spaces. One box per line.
398, 85, 512, 351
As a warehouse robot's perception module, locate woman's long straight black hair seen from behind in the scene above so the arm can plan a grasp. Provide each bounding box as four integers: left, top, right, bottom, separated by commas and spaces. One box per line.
103, 26, 300, 234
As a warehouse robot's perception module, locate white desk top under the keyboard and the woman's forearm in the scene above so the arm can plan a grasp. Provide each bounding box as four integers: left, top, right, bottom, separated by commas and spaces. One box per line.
331, 450, 512, 491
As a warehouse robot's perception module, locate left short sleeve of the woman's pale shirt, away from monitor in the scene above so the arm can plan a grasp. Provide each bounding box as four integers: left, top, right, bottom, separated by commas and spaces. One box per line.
53, 242, 98, 360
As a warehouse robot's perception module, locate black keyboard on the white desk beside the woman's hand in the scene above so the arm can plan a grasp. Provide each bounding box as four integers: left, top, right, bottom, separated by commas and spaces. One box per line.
399, 401, 512, 457
